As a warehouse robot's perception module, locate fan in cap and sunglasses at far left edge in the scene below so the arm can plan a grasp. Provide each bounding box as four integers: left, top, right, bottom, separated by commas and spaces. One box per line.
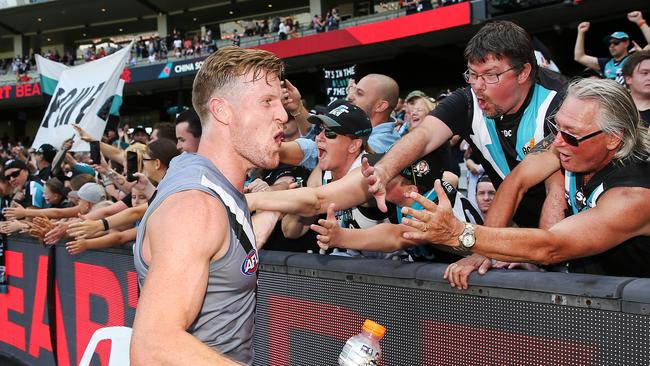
4, 159, 47, 208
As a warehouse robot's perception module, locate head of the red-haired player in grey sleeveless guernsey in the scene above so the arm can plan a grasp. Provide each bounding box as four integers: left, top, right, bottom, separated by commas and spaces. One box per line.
192, 47, 287, 170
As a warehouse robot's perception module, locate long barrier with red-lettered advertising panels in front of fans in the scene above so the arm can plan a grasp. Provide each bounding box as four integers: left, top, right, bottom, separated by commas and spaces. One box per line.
0, 237, 650, 365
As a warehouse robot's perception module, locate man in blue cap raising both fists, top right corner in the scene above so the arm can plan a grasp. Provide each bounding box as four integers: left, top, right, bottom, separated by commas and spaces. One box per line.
573, 11, 650, 85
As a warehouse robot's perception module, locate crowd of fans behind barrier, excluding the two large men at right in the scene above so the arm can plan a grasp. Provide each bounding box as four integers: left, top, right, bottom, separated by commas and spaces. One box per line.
0, 9, 650, 281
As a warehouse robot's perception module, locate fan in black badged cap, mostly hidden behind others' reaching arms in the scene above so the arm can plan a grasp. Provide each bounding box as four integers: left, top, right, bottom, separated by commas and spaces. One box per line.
311, 150, 483, 263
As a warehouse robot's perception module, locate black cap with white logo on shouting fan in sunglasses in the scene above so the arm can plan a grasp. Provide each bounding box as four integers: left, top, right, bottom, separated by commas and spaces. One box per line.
307, 99, 372, 138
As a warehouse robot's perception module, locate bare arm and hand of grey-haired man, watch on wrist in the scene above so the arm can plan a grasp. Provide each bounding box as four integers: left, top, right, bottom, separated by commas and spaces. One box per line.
403, 183, 650, 264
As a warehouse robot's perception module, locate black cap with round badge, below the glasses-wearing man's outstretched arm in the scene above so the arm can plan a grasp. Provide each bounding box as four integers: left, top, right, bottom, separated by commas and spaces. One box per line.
364, 150, 444, 194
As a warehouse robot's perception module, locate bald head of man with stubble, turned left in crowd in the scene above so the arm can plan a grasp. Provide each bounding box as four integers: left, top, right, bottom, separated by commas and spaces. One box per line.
348, 74, 399, 124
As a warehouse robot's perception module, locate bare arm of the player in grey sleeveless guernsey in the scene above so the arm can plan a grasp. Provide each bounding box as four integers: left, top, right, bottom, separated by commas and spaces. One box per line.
131, 191, 236, 365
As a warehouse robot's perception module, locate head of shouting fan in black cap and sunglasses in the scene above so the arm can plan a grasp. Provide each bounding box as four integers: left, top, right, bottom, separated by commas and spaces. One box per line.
308, 100, 372, 179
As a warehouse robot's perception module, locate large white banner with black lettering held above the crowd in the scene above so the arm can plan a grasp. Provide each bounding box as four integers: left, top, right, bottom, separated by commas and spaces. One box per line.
32, 43, 133, 151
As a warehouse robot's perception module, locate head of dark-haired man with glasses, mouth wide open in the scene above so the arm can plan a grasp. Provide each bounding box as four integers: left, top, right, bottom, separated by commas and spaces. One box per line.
464, 20, 537, 118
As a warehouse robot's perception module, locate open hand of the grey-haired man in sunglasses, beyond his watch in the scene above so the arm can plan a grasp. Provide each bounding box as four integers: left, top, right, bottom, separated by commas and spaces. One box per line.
402, 179, 464, 247
